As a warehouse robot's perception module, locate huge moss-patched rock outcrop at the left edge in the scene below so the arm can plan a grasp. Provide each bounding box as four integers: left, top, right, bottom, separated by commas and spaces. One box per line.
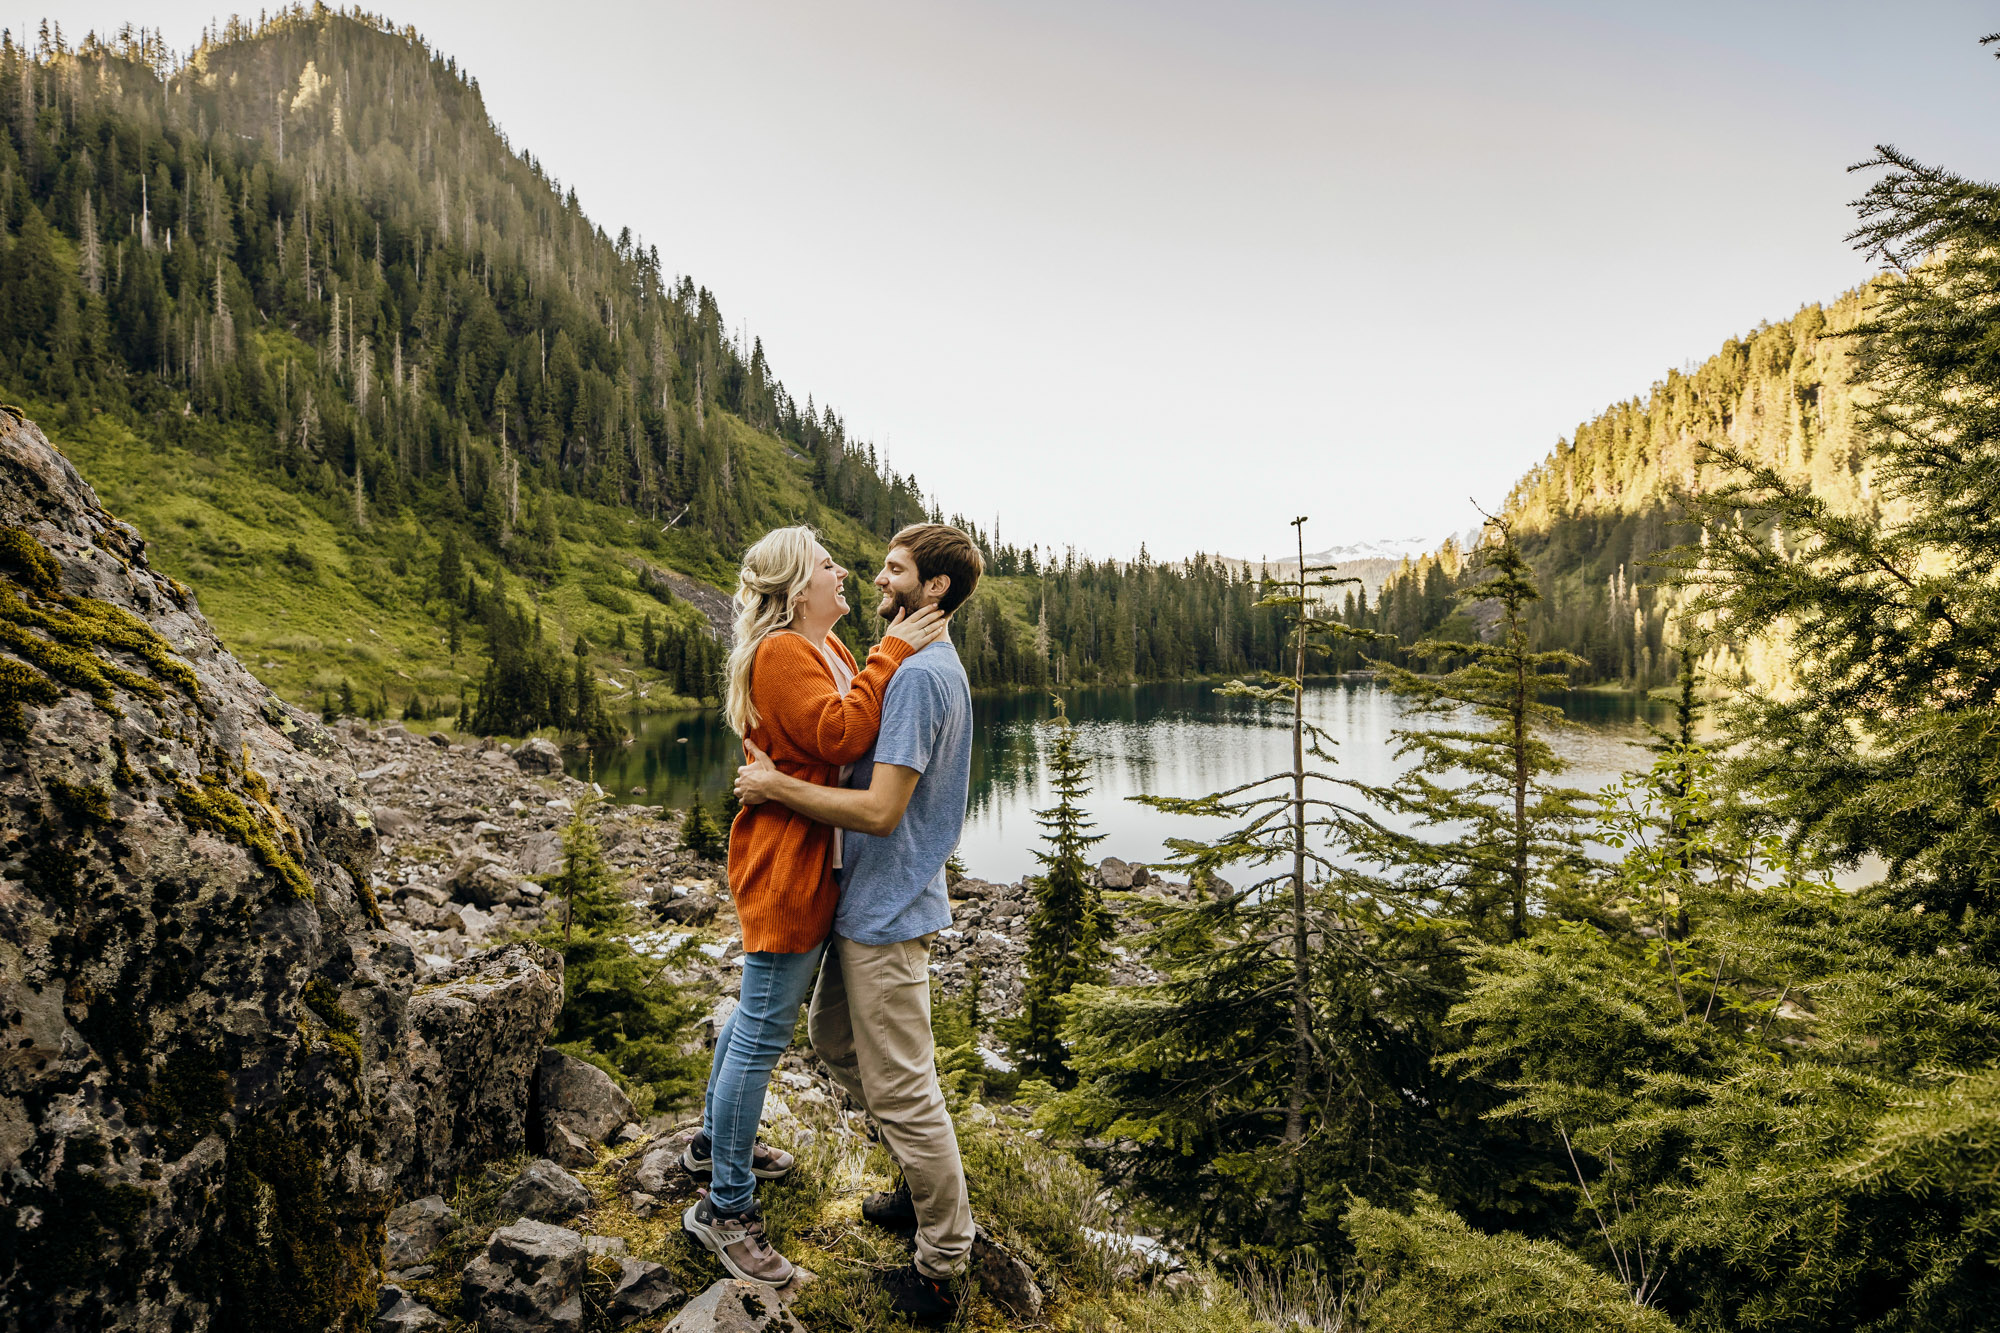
0, 408, 560, 1333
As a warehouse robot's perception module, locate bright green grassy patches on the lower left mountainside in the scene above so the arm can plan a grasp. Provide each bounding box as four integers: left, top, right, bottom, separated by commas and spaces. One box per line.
24, 390, 908, 711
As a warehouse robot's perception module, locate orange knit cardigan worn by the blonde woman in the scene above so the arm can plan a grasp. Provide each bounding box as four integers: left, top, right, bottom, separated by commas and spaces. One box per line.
730, 632, 910, 953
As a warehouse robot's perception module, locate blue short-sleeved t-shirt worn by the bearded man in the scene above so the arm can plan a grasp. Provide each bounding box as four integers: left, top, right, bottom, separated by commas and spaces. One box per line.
834, 638, 972, 945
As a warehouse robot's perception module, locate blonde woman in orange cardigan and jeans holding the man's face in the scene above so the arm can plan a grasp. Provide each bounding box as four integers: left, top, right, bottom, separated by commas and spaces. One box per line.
682, 528, 948, 1287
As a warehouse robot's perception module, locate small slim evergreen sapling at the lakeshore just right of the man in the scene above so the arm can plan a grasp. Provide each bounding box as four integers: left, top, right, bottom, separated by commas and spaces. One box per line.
1004, 697, 1112, 1087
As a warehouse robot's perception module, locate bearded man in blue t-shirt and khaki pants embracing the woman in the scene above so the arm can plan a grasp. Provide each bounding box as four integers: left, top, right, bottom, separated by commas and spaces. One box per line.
736, 522, 986, 1321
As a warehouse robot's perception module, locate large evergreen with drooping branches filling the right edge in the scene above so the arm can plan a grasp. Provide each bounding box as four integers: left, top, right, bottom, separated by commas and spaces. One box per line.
1454, 116, 2000, 1333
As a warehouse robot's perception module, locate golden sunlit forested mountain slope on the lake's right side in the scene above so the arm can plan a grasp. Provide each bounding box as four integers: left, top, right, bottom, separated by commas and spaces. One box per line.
1362, 288, 1878, 687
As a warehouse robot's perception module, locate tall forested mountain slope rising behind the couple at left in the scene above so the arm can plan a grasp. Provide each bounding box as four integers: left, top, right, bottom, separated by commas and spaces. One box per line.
0, 8, 1274, 725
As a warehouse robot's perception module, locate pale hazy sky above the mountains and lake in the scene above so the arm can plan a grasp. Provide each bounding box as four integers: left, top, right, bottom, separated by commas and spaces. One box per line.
16, 0, 2000, 556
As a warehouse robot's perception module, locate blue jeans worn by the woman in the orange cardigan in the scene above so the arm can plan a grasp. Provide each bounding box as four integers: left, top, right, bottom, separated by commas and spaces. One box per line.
702, 945, 824, 1213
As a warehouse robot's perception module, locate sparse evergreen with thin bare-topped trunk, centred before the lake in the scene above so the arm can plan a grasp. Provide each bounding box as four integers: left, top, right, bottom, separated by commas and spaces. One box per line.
1046, 518, 1430, 1253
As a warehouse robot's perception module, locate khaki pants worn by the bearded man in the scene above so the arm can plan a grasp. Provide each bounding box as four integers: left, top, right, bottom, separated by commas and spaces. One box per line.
806, 935, 972, 1277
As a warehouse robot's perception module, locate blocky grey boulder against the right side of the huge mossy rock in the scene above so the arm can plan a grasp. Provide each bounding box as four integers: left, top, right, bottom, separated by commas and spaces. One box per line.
388, 945, 562, 1195
